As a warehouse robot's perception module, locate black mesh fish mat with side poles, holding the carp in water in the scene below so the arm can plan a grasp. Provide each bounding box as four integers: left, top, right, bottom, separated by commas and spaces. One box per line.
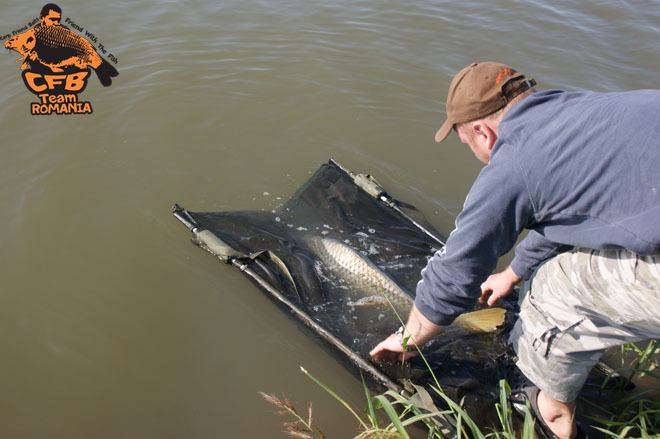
174, 159, 648, 436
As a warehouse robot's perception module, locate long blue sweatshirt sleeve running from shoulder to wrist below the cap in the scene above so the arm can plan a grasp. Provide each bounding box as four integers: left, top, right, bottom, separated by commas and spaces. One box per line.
415, 151, 533, 326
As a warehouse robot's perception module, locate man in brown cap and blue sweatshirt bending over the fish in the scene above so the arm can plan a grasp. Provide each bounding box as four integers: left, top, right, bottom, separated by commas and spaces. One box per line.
371, 62, 660, 438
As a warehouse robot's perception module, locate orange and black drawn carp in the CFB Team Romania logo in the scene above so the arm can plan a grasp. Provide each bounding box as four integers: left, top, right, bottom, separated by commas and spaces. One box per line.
5, 25, 119, 87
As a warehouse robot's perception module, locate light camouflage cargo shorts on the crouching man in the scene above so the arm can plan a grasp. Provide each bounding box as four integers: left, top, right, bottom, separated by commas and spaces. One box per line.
510, 249, 660, 402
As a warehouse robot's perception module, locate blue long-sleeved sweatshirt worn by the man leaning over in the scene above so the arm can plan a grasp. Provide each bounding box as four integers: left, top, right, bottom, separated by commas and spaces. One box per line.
415, 90, 660, 325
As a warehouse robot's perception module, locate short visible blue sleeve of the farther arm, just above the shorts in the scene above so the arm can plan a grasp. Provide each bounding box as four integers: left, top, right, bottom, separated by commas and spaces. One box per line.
511, 230, 573, 280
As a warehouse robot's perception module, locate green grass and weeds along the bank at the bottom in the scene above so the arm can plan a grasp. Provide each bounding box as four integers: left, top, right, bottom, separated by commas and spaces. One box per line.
262, 340, 660, 439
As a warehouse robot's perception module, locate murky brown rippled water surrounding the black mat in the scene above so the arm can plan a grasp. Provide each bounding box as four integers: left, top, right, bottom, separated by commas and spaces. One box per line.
0, 0, 660, 439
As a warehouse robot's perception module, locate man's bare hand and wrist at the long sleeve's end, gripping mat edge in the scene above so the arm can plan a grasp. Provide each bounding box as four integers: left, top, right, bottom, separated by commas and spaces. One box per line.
369, 305, 443, 361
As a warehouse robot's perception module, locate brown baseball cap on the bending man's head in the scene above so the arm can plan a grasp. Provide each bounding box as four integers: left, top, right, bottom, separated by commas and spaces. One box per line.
435, 62, 536, 142
